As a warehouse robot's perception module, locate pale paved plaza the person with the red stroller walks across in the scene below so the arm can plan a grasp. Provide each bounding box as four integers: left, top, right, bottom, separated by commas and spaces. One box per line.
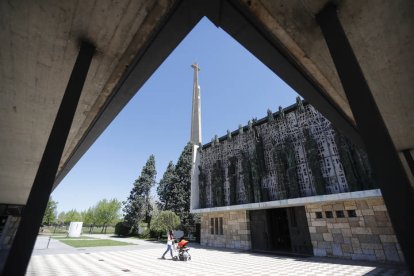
27, 236, 409, 276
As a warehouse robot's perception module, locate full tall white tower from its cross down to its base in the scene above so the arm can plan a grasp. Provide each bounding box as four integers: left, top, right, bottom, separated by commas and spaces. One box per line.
190, 63, 201, 209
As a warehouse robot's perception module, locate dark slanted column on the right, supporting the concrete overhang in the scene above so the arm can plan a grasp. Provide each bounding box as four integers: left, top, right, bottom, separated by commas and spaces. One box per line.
316, 4, 414, 274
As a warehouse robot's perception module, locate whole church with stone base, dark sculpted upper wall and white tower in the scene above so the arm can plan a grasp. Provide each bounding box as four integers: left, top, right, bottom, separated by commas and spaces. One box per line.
191, 66, 403, 262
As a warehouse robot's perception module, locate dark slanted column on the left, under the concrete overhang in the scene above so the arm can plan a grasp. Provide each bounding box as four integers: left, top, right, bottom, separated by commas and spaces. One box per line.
2, 42, 95, 276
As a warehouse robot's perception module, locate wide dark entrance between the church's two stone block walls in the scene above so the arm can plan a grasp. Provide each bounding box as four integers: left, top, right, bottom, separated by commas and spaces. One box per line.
250, 207, 312, 255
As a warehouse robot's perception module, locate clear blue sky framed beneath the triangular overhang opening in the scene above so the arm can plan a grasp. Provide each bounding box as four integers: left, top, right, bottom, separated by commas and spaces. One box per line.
52, 19, 297, 212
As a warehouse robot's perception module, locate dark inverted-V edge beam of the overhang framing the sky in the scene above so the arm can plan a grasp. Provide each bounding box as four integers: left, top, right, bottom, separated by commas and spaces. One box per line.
54, 0, 363, 187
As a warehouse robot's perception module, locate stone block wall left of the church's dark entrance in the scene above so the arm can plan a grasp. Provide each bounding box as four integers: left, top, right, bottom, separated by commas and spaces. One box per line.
200, 210, 251, 250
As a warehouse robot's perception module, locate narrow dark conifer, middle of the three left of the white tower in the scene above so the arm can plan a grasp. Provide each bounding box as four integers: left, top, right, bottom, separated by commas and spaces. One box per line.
157, 161, 178, 210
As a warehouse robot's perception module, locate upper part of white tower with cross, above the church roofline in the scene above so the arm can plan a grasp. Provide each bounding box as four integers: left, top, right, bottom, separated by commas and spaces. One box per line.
190, 63, 201, 145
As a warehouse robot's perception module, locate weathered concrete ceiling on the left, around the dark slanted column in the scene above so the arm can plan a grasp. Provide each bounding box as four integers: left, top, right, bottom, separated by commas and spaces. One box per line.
0, 0, 174, 204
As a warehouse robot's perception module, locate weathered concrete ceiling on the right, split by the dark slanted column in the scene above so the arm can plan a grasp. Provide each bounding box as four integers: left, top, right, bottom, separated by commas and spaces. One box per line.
242, 0, 414, 153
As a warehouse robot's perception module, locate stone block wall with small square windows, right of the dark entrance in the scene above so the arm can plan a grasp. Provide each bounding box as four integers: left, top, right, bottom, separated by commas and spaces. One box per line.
305, 197, 404, 262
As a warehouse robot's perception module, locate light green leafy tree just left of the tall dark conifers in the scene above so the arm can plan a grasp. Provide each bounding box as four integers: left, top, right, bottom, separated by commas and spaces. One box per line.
95, 199, 121, 234
